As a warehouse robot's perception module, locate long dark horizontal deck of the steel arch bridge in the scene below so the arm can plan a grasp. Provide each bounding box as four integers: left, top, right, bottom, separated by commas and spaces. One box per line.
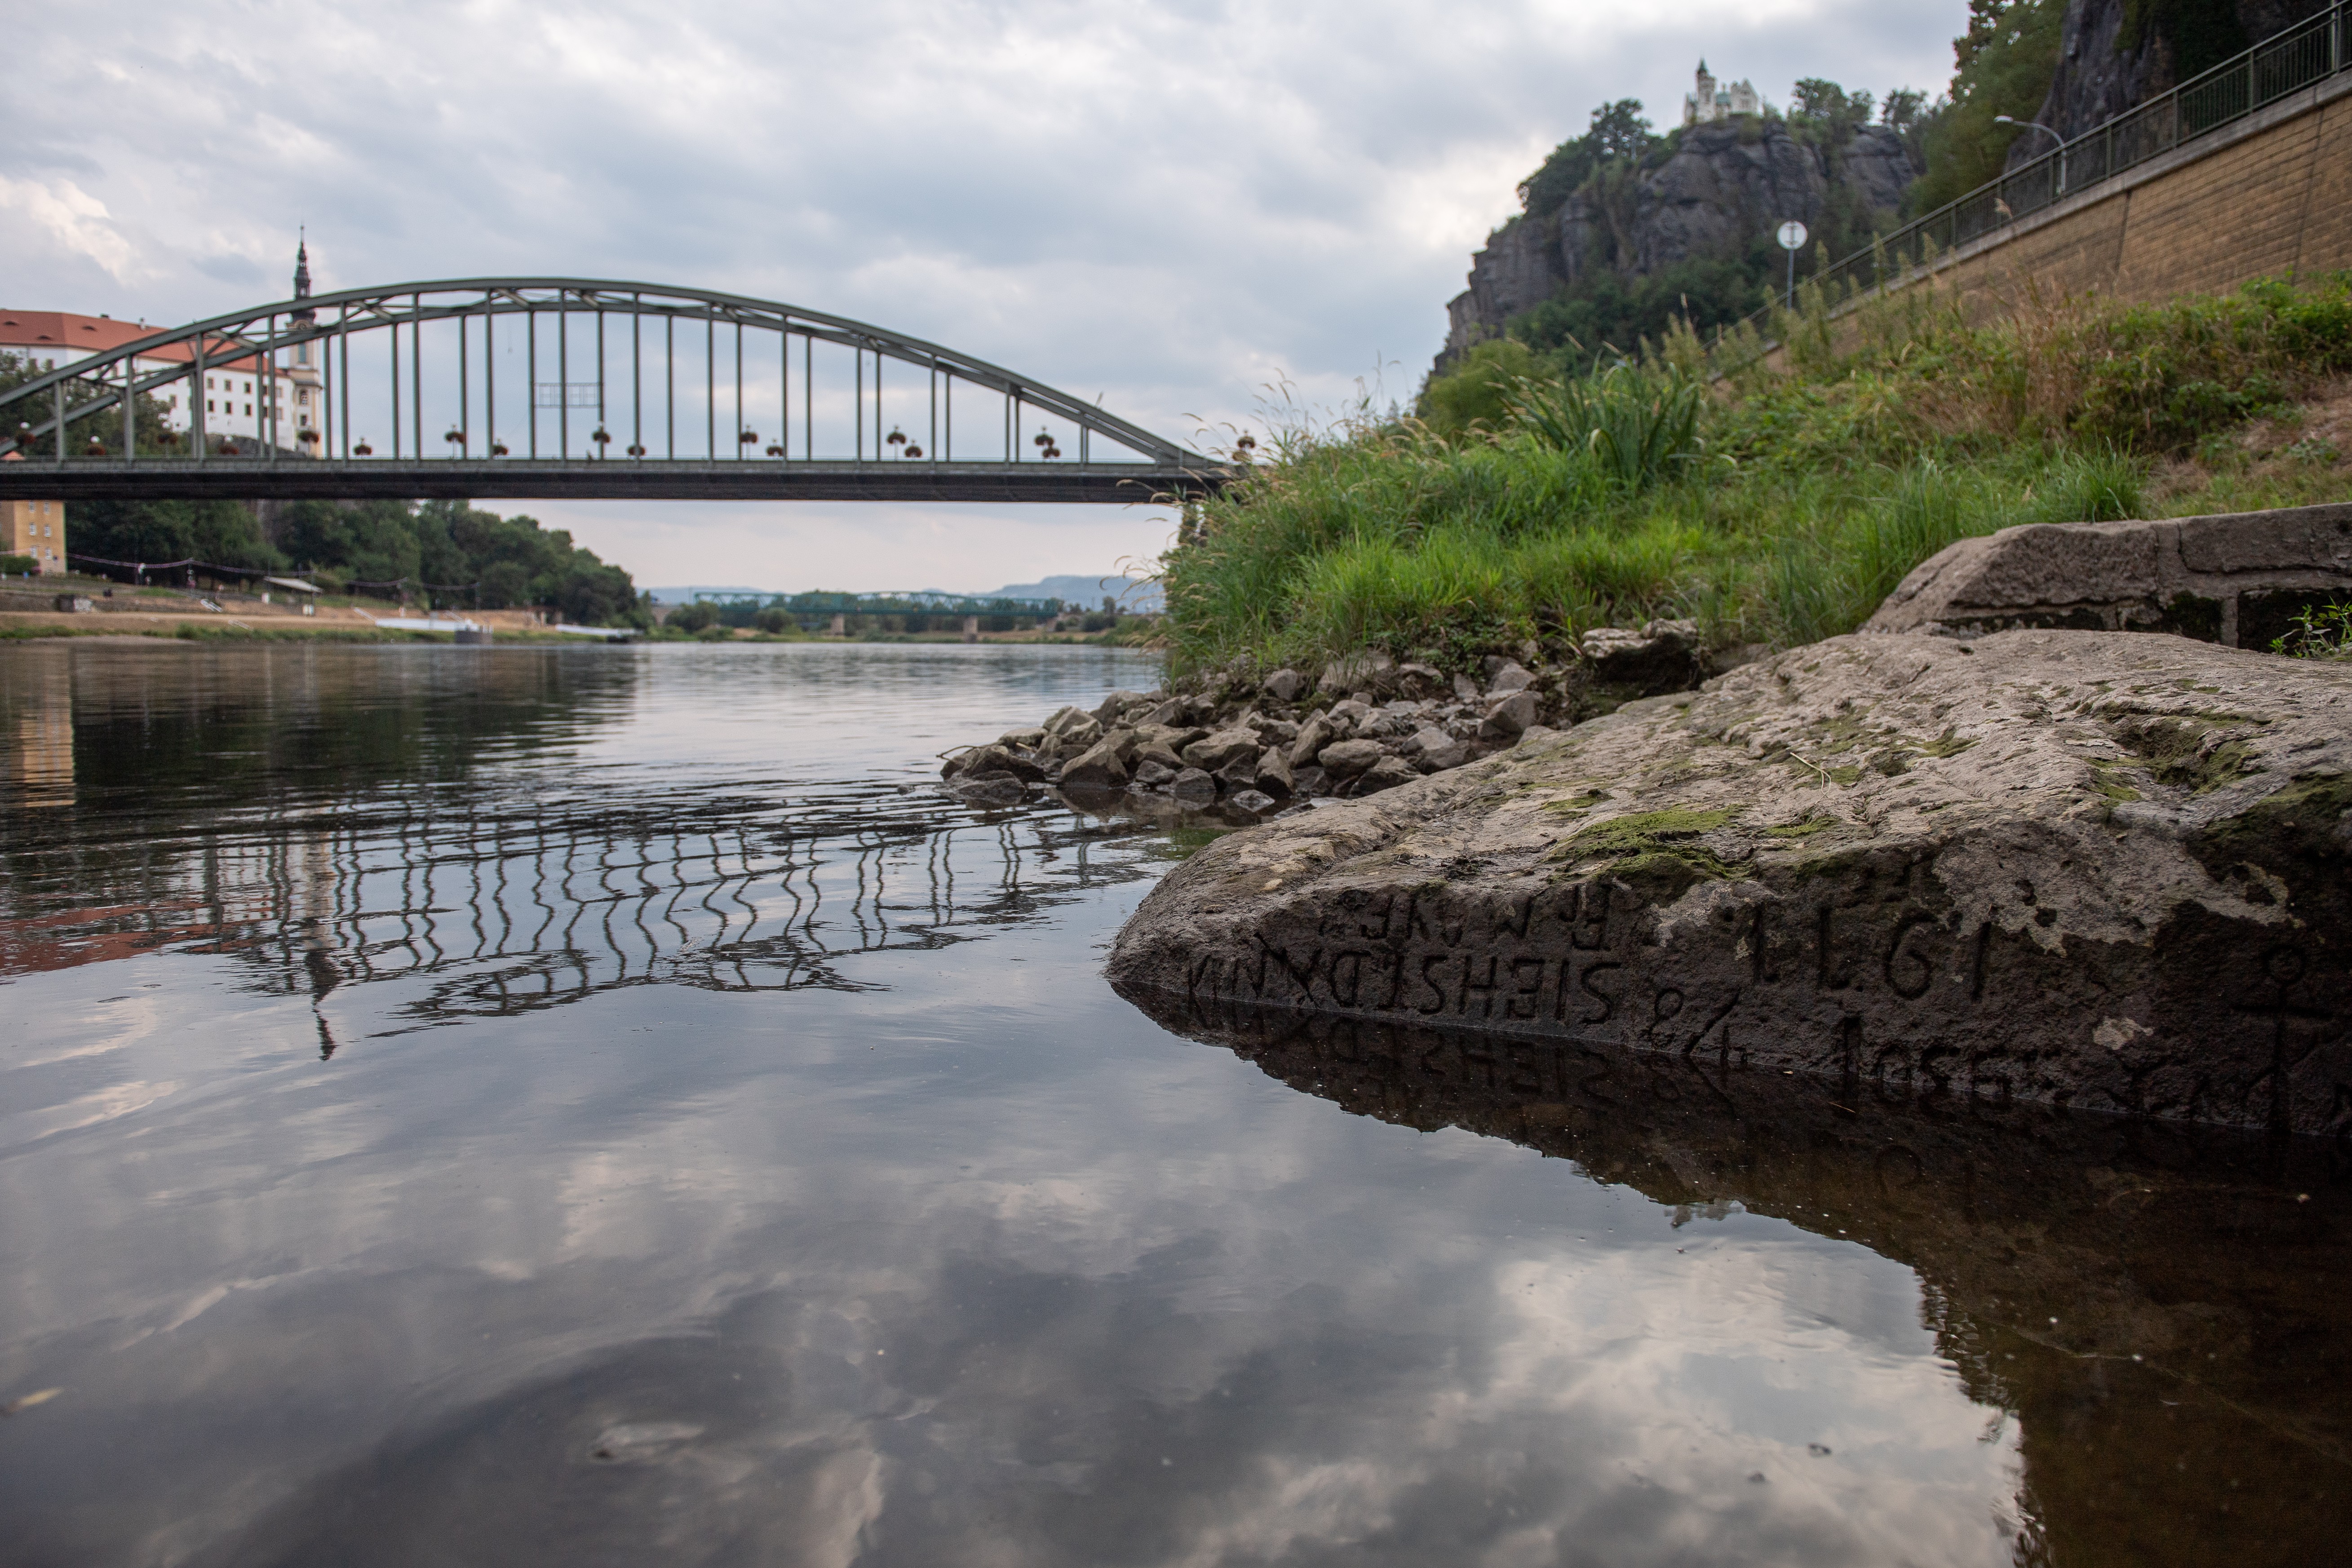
0, 456, 1225, 503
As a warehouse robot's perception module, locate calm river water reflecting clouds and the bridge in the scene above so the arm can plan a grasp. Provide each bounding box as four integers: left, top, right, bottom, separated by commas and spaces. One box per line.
0, 642, 2352, 1568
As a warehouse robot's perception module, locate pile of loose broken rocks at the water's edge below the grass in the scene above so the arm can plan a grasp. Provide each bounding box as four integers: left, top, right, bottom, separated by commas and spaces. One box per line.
941, 620, 1710, 813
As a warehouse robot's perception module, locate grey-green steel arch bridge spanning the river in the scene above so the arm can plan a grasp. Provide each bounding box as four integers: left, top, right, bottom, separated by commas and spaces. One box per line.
0, 277, 1225, 501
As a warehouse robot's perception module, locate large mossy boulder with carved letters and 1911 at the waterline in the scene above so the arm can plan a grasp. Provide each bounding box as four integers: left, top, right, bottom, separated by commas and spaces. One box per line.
1110, 630, 2352, 1133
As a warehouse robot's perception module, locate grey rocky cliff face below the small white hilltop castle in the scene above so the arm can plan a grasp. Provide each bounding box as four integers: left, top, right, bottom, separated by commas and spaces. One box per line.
1437, 118, 1919, 372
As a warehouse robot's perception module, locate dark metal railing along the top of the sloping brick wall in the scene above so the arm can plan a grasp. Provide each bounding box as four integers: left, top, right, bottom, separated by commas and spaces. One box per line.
1748, 0, 2352, 350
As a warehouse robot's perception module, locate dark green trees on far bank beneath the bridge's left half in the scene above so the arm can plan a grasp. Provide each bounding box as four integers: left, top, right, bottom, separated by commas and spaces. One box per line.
68, 501, 644, 625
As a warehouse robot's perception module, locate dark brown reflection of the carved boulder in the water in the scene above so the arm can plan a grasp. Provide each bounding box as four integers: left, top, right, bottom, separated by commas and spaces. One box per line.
1129, 990, 2352, 1568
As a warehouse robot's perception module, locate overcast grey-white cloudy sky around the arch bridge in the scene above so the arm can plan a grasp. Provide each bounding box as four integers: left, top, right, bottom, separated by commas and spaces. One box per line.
0, 0, 1966, 588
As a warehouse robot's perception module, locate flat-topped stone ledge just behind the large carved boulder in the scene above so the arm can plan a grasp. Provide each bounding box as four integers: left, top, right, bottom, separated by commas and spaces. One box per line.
1863, 505, 2352, 649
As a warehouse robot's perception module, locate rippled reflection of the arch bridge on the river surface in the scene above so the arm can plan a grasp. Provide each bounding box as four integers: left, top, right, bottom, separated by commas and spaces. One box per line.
0, 788, 1131, 1051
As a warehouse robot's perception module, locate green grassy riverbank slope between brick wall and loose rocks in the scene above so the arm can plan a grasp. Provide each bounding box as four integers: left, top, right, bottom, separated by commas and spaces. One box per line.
1164, 275, 2352, 670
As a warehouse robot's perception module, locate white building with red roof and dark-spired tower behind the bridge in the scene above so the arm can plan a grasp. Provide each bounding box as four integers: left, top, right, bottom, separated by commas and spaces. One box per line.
0, 247, 327, 454
